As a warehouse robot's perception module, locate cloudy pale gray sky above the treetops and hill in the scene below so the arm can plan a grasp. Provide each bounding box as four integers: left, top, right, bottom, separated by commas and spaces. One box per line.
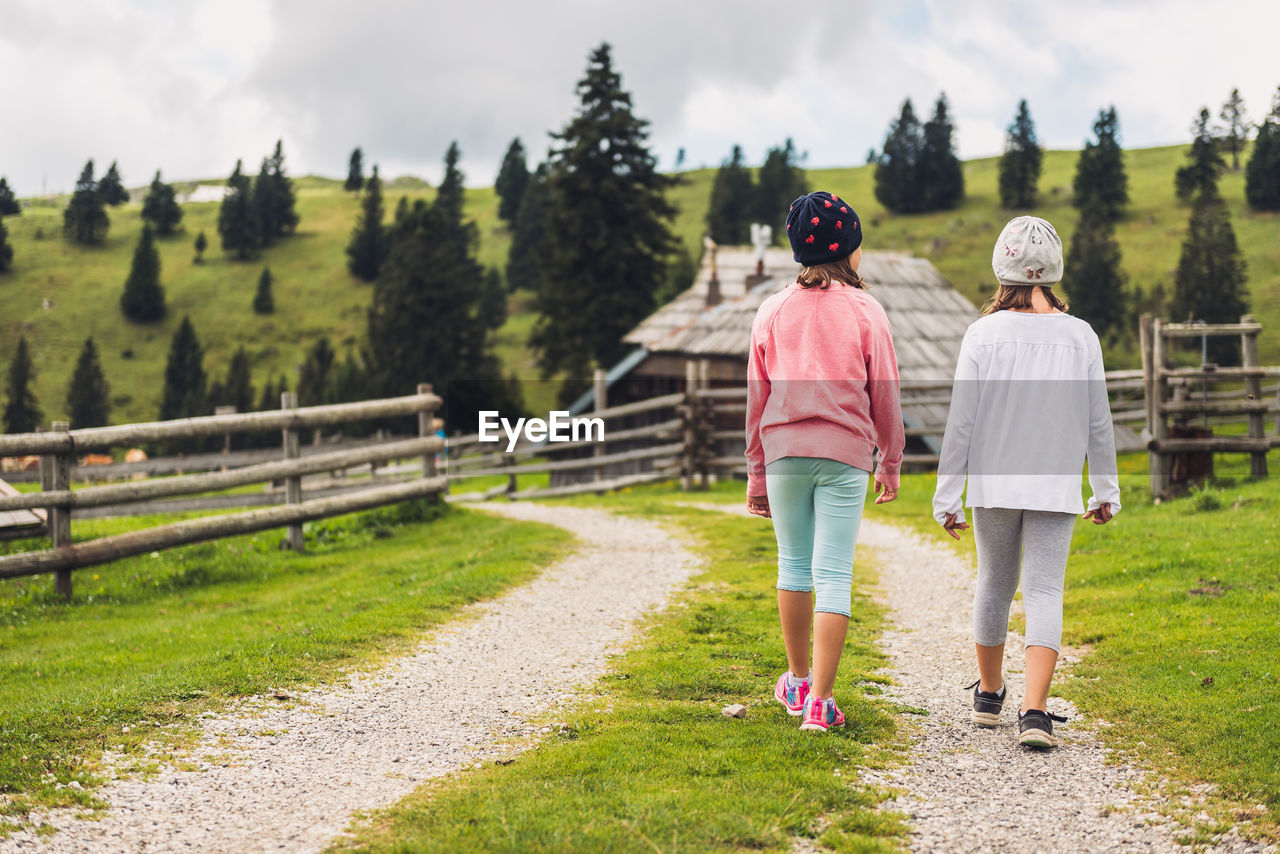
0, 0, 1280, 195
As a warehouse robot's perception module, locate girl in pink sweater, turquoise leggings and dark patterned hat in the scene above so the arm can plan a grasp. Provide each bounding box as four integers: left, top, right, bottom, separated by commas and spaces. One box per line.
746, 192, 904, 731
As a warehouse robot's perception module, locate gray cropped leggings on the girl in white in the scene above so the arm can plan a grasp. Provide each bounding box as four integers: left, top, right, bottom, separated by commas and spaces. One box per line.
973, 507, 1075, 652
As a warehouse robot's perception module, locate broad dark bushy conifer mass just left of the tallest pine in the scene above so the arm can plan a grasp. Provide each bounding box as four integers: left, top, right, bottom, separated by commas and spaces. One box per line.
367, 174, 522, 430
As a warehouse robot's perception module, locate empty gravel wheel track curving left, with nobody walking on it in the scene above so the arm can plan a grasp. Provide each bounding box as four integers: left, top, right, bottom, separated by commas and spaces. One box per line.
0, 503, 698, 854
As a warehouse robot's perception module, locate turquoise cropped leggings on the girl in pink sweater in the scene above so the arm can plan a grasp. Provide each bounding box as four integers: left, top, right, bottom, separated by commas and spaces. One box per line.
764, 457, 868, 617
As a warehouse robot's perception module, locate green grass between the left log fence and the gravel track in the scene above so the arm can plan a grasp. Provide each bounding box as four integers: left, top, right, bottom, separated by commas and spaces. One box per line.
0, 502, 570, 826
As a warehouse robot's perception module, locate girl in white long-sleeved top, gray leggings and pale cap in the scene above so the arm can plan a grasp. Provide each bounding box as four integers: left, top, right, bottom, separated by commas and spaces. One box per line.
933, 216, 1120, 748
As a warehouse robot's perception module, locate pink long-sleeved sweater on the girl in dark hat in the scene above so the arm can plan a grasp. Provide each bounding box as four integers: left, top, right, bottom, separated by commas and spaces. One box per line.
746, 283, 905, 495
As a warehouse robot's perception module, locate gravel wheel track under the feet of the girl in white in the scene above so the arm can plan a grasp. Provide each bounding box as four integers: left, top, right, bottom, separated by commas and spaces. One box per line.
691, 504, 1276, 851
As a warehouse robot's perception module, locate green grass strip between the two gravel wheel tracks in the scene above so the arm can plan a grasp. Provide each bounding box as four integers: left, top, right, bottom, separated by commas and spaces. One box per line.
343, 496, 902, 851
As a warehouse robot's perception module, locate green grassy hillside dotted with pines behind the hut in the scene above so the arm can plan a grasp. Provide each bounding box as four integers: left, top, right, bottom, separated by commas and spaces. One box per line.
0, 146, 1280, 423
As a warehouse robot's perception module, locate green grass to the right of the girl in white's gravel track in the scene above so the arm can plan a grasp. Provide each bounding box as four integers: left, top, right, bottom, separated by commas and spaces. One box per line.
865, 452, 1280, 839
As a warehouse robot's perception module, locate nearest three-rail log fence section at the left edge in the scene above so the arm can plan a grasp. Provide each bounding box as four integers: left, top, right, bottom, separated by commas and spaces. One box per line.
0, 384, 448, 597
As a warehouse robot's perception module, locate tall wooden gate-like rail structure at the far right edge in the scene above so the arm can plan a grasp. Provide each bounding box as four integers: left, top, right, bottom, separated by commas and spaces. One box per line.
1139, 315, 1280, 498
